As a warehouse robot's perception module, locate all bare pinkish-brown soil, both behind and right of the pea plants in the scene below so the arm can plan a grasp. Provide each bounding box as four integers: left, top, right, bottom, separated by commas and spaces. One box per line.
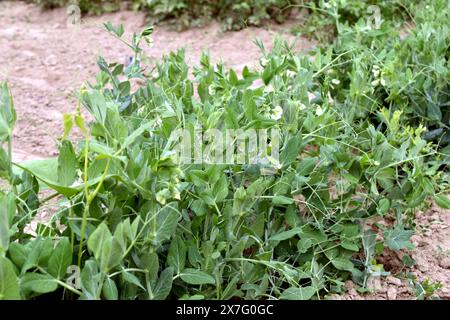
0, 1, 450, 299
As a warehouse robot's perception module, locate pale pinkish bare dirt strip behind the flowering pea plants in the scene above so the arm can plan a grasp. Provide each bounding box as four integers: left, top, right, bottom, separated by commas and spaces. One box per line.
0, 1, 313, 161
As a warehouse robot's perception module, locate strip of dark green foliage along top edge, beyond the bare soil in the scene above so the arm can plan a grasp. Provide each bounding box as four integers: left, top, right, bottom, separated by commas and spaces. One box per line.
29, 0, 419, 31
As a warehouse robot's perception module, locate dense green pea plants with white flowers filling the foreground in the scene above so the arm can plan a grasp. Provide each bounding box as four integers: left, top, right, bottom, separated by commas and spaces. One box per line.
0, 1, 450, 300
